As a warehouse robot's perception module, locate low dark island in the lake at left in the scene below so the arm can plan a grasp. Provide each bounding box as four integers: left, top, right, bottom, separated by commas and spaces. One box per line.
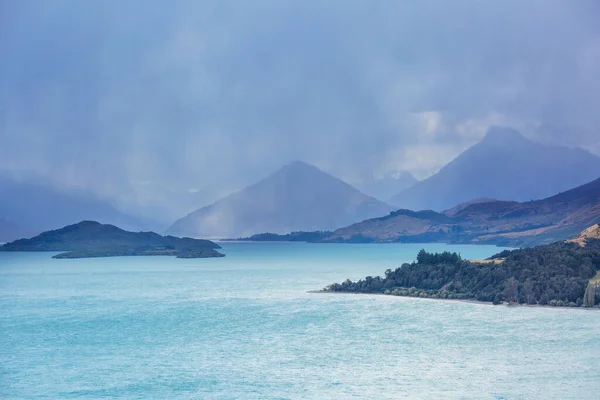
0, 221, 225, 258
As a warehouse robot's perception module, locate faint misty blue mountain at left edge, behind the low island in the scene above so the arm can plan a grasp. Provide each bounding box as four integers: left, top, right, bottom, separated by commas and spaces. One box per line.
0, 176, 153, 240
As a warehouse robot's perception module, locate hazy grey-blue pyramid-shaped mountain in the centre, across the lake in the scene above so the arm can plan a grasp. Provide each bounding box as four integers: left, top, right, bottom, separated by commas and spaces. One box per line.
167, 161, 391, 237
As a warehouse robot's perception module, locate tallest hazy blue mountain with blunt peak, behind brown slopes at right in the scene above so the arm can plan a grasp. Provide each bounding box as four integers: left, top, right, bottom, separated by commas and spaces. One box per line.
390, 127, 600, 211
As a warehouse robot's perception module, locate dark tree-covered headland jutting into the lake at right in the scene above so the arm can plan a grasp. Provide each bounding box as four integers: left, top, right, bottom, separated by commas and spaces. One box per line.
324, 239, 600, 307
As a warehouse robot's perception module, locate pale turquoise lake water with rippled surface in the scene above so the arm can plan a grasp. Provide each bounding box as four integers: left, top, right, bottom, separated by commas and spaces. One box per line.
0, 243, 600, 399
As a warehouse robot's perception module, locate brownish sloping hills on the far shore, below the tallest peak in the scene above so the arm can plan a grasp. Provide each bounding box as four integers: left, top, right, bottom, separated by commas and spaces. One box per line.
321, 179, 600, 246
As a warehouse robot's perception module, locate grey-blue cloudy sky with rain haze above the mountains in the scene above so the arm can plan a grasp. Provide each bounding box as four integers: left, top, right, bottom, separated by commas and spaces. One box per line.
0, 0, 600, 219
